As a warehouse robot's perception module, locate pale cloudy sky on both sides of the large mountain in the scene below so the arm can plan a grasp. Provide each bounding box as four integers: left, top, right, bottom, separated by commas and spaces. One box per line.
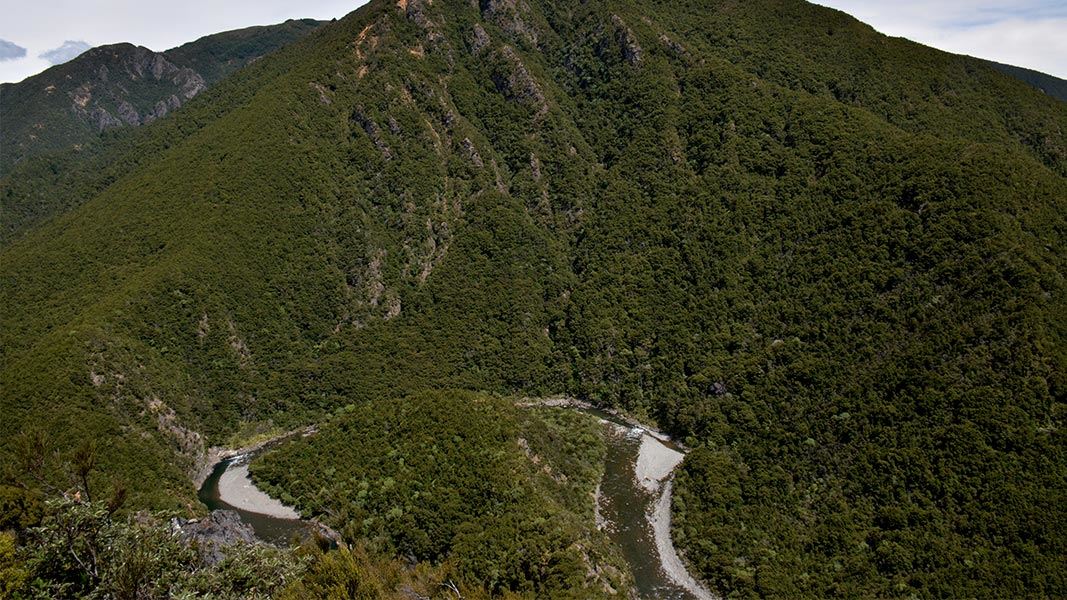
0, 0, 1067, 81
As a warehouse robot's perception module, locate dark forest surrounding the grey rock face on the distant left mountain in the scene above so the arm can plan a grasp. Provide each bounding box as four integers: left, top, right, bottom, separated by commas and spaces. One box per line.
0, 20, 321, 244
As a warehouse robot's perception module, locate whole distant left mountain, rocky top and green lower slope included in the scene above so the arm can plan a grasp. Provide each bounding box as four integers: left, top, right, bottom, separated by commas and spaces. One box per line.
0, 19, 322, 243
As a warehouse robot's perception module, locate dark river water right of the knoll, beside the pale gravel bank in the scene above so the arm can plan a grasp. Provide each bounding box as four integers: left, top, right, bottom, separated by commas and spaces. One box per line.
580, 409, 696, 600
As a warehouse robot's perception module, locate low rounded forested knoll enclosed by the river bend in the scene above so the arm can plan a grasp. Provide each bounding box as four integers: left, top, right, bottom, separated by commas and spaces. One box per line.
253, 392, 628, 598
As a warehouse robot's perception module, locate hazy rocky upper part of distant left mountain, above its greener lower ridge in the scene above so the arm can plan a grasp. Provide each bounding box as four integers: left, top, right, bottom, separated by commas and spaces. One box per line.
0, 19, 321, 174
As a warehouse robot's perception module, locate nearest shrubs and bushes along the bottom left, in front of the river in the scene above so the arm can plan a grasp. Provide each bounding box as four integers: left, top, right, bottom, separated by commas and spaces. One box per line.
0, 499, 511, 600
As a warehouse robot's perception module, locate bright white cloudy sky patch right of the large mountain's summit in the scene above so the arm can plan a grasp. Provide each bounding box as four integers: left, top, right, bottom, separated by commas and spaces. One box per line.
817, 0, 1067, 79
